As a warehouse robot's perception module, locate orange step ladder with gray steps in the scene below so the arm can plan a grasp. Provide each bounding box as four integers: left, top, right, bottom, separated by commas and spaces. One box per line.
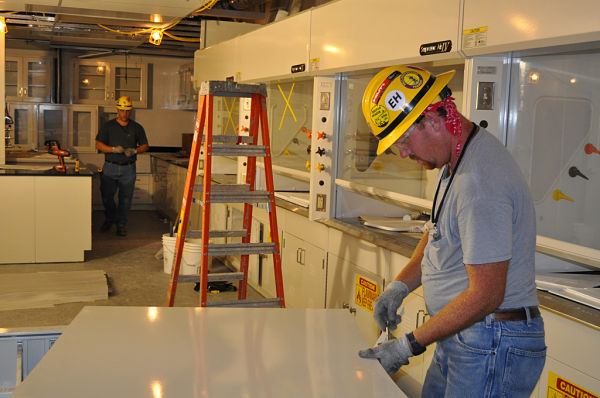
166, 81, 285, 308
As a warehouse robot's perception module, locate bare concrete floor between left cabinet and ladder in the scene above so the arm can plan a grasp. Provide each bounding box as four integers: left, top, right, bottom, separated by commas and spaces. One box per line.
0, 211, 262, 328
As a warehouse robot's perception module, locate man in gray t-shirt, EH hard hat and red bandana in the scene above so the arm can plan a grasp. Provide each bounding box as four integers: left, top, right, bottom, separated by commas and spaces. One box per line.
359, 66, 546, 398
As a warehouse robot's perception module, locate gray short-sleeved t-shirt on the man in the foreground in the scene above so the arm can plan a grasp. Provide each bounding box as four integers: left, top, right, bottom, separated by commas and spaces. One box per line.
421, 129, 538, 315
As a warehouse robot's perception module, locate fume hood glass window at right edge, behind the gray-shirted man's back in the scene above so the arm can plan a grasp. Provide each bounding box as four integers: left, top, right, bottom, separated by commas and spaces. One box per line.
507, 53, 600, 249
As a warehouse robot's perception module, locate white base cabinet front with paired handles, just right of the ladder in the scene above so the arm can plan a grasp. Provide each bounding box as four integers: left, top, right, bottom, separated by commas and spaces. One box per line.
282, 233, 327, 308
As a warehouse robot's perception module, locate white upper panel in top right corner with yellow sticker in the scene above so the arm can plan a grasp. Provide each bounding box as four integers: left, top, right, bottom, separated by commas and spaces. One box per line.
461, 0, 600, 56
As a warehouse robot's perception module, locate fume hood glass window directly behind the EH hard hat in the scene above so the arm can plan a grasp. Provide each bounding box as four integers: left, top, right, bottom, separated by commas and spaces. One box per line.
337, 64, 464, 204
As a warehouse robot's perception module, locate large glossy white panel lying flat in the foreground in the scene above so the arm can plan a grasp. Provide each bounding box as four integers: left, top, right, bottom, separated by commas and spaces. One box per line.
11, 306, 406, 398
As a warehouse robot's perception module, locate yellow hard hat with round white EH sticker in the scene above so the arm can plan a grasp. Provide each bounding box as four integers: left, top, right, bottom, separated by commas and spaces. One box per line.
362, 65, 456, 155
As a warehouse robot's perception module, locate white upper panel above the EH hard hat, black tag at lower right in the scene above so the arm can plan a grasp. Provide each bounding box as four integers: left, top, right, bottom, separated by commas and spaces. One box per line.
310, 0, 460, 73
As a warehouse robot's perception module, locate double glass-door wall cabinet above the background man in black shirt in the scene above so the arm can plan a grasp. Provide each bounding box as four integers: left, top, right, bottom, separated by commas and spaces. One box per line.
73, 60, 148, 108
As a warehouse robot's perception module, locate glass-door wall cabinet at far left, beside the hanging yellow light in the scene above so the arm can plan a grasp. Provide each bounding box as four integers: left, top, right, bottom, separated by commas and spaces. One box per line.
5, 56, 52, 102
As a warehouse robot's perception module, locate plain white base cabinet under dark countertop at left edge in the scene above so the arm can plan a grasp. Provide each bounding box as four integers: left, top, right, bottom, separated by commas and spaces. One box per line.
0, 176, 92, 263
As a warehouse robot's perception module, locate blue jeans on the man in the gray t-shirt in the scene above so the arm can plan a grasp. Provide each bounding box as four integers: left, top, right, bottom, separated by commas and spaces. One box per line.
421, 310, 546, 398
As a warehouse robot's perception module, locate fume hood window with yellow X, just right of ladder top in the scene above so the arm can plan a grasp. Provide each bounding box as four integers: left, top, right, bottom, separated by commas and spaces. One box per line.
267, 79, 314, 175
